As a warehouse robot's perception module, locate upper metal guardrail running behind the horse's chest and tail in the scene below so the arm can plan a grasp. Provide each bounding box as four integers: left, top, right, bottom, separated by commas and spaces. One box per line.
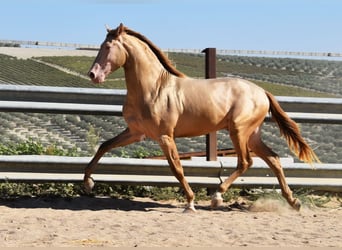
0, 84, 342, 124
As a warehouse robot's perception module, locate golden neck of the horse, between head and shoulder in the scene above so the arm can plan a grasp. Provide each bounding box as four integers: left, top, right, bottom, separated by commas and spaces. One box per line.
124, 37, 165, 98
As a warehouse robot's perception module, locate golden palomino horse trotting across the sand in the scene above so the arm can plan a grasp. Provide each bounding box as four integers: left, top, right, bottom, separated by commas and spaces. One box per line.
84, 24, 319, 211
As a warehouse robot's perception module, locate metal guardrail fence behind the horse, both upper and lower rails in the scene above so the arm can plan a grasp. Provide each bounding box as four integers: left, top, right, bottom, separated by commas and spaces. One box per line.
0, 85, 342, 192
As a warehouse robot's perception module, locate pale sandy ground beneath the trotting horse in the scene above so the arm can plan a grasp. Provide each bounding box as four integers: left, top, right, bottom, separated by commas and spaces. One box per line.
0, 197, 342, 247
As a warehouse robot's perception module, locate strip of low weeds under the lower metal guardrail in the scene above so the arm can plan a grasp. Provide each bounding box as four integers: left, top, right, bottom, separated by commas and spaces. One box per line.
0, 182, 342, 210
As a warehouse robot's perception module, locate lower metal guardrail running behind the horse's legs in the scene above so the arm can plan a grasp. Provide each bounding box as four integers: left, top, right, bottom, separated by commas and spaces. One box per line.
0, 155, 342, 192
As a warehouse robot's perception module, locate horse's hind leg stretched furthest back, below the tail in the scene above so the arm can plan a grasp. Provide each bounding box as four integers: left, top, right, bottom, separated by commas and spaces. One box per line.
248, 129, 301, 211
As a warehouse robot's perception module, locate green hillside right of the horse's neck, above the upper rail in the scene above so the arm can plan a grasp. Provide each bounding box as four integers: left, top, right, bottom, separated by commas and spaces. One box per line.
169, 53, 342, 96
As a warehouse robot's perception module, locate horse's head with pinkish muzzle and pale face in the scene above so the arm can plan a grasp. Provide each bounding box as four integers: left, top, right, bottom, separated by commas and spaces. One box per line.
88, 23, 127, 83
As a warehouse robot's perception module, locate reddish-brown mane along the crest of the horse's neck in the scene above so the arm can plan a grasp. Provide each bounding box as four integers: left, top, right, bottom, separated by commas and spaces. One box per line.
108, 24, 185, 77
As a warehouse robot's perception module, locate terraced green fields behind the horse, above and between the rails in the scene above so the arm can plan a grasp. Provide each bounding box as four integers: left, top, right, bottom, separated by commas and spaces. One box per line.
0, 50, 342, 162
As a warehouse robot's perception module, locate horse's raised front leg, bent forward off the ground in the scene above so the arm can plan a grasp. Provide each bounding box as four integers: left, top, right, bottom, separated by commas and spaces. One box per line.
83, 128, 144, 193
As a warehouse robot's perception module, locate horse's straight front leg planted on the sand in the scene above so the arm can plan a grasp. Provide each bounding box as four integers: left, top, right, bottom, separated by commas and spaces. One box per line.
159, 135, 196, 212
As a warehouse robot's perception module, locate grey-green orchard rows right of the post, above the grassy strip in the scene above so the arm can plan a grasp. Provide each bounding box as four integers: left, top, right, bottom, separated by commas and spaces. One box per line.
218, 56, 342, 97
